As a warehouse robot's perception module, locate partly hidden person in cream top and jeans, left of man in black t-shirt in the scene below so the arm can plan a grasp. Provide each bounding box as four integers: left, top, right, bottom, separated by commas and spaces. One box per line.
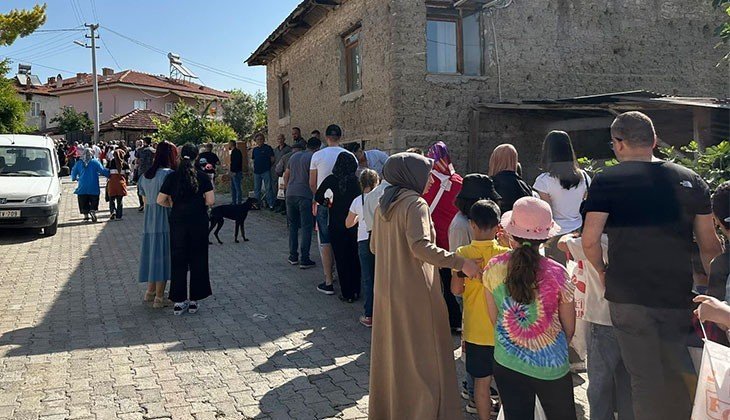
558, 233, 633, 419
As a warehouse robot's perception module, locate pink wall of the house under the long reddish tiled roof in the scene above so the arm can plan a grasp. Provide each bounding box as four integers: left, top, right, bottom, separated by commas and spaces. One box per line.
60, 86, 222, 122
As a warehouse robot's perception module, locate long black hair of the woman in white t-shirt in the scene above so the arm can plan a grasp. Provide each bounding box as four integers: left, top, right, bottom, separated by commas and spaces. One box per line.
540, 131, 582, 190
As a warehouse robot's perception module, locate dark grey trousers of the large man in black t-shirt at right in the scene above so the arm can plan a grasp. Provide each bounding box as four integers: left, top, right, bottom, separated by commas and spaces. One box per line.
609, 302, 697, 420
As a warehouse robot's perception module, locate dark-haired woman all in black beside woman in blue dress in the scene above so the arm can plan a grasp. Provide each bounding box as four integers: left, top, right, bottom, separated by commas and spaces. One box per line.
157, 144, 215, 315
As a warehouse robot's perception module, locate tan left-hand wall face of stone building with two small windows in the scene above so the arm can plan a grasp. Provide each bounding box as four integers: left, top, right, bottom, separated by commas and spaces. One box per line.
267, 0, 398, 147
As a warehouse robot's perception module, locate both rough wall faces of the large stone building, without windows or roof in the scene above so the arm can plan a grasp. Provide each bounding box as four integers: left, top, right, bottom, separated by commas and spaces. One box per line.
258, 0, 729, 175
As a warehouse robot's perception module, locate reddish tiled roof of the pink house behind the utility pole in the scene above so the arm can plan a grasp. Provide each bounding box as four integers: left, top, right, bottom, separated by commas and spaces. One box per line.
47, 70, 229, 98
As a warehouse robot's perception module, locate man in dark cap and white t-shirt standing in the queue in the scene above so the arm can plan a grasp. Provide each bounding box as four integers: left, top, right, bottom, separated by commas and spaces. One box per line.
309, 124, 350, 295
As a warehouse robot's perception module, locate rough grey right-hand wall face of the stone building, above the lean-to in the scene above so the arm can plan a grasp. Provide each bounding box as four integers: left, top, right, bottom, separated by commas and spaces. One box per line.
393, 0, 729, 172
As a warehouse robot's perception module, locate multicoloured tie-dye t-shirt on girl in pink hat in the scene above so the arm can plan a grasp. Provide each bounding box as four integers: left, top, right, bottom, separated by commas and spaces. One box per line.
483, 253, 573, 380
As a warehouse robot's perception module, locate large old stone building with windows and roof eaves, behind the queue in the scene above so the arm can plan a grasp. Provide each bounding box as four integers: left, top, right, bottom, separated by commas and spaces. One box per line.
247, 0, 728, 174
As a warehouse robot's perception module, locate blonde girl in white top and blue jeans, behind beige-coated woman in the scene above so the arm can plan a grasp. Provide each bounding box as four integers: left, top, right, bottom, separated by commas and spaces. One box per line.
345, 169, 380, 328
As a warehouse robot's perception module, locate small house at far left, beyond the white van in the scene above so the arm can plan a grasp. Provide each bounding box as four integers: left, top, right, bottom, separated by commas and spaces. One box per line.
13, 64, 60, 131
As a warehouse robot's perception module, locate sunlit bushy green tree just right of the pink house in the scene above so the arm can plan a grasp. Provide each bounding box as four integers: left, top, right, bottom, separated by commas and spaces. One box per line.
154, 102, 236, 145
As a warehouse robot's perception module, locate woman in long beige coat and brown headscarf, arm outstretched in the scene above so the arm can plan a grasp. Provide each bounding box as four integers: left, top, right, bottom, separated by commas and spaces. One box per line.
369, 153, 479, 420
